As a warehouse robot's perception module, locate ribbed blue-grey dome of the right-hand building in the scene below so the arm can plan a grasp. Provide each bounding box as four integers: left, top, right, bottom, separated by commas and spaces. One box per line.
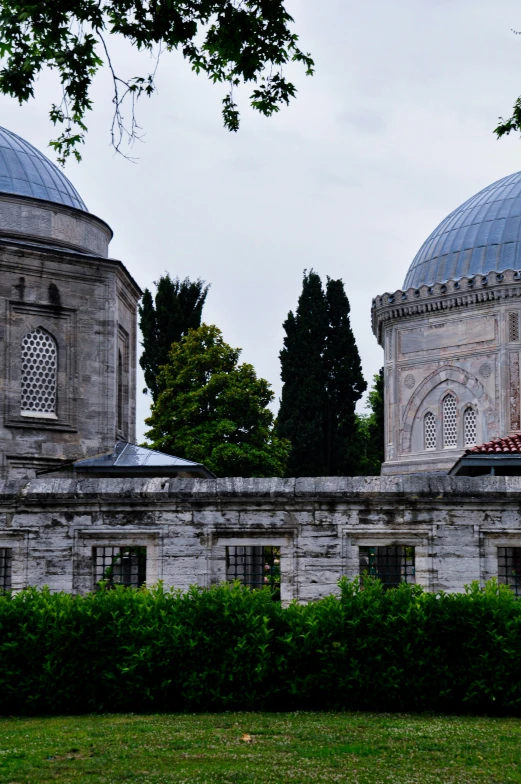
403, 172, 521, 290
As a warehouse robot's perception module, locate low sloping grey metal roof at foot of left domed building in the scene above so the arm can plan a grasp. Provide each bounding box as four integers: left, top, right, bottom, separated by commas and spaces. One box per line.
74, 441, 213, 478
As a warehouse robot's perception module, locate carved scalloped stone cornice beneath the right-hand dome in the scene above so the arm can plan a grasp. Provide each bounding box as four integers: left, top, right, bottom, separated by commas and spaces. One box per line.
371, 269, 521, 345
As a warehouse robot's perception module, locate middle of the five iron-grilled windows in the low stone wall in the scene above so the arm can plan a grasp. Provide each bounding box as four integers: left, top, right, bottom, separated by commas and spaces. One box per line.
226, 545, 280, 599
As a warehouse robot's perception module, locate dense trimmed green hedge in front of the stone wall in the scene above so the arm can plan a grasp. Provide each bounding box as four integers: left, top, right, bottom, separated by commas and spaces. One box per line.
0, 580, 521, 715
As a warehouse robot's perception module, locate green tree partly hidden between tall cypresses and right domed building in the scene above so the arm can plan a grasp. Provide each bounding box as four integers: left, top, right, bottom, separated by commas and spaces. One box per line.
357, 368, 385, 476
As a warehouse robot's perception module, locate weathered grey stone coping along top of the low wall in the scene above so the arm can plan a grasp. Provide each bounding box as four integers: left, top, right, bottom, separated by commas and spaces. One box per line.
0, 474, 521, 502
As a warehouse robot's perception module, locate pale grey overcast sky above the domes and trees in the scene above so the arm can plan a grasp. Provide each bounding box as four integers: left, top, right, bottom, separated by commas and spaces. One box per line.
0, 0, 521, 439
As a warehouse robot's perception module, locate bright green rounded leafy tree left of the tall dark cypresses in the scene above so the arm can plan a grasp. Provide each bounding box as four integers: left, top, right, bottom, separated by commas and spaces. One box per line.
146, 324, 289, 476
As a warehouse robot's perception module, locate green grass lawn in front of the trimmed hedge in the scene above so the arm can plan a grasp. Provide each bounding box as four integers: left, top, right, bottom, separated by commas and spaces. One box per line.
0, 713, 521, 784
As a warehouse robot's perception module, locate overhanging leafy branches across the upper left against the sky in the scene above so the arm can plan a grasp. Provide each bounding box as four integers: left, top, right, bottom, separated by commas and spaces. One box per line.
0, 0, 314, 163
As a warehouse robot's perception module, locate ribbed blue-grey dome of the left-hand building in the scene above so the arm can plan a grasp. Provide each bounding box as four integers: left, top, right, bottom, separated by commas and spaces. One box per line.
0, 128, 88, 212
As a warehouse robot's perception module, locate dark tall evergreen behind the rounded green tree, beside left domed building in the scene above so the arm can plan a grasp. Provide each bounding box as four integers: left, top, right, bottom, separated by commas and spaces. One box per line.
139, 273, 208, 400
